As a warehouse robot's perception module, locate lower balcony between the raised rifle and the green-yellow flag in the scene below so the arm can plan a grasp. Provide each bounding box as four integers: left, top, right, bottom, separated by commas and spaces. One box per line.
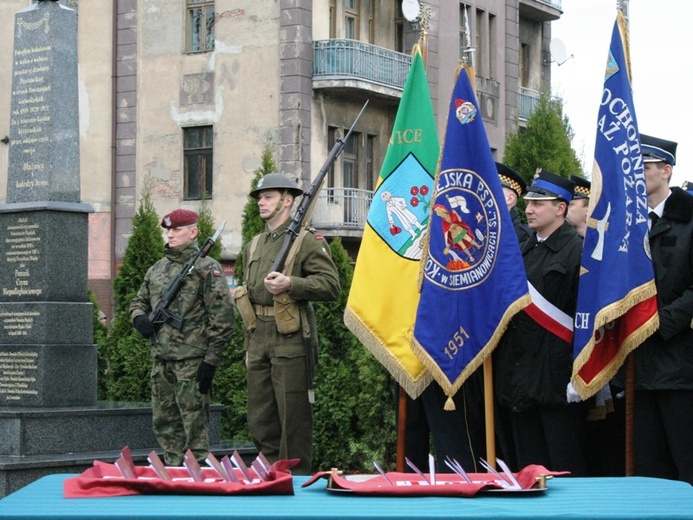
311, 188, 373, 237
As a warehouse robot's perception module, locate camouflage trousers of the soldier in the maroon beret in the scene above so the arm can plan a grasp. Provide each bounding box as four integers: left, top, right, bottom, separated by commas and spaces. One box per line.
151, 358, 210, 466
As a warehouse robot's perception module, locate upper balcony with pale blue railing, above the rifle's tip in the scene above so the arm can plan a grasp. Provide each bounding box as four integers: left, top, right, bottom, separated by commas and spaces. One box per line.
313, 40, 411, 99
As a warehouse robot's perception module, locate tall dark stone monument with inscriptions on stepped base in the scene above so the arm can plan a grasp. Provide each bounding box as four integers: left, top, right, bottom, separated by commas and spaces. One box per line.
0, 1, 247, 497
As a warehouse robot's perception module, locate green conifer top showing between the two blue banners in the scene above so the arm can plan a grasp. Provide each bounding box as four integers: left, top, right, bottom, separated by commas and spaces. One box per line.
503, 93, 582, 184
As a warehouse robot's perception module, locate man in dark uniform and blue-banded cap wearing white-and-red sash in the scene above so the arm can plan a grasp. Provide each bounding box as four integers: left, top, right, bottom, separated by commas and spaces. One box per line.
494, 170, 585, 475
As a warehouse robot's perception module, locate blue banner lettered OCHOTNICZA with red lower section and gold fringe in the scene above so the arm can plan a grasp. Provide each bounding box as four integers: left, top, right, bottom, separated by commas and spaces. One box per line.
572, 13, 659, 399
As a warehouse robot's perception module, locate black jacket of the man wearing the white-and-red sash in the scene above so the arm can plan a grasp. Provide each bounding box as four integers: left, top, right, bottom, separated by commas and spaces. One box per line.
494, 222, 582, 412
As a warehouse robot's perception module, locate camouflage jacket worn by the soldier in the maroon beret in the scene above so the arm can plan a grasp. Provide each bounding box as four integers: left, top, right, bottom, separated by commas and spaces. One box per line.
130, 242, 233, 366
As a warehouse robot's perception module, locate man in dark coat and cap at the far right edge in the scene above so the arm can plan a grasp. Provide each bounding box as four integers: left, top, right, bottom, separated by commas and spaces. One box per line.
634, 134, 693, 484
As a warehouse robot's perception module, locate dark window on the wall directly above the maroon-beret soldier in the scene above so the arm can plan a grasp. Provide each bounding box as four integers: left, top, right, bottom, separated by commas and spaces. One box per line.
183, 126, 214, 199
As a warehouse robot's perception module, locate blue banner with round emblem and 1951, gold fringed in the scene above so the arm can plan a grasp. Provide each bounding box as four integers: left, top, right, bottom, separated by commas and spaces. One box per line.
413, 65, 529, 396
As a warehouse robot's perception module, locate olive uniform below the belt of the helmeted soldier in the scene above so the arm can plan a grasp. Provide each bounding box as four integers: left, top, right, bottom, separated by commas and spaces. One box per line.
248, 319, 313, 475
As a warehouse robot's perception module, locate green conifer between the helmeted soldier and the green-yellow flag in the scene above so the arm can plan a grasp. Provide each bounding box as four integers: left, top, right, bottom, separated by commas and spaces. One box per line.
313, 237, 396, 472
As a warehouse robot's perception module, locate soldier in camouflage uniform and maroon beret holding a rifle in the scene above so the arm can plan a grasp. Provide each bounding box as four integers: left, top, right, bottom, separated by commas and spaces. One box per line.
130, 209, 233, 466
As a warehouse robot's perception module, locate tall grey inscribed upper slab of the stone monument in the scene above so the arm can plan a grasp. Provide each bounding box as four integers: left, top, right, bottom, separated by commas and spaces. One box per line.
7, 2, 80, 203
